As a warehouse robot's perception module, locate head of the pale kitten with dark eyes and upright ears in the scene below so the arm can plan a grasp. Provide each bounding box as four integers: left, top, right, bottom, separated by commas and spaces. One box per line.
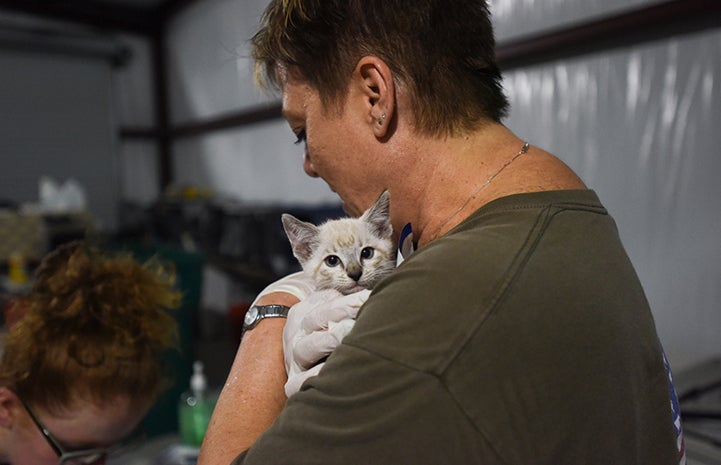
281, 191, 396, 295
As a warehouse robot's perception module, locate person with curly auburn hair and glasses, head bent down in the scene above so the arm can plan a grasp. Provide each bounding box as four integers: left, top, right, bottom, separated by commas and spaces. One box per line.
0, 242, 181, 465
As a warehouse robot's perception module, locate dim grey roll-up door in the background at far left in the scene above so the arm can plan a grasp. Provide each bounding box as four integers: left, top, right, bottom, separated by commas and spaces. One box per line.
0, 45, 119, 230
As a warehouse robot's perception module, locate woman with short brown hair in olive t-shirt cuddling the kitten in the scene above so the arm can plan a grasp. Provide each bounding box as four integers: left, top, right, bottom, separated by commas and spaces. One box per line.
199, 0, 683, 465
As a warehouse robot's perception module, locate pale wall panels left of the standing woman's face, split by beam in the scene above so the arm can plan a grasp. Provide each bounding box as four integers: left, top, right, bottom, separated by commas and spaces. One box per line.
169, 0, 337, 204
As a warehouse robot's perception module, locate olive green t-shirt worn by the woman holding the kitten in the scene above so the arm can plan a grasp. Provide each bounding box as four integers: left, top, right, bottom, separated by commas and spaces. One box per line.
234, 190, 679, 465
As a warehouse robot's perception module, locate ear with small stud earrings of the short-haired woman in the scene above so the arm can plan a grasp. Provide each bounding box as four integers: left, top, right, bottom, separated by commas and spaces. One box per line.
356, 55, 396, 138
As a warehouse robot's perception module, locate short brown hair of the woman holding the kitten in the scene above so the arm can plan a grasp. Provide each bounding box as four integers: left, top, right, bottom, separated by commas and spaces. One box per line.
251, 0, 508, 135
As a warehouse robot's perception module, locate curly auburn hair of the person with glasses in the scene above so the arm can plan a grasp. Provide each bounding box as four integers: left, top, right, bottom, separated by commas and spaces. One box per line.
0, 242, 181, 412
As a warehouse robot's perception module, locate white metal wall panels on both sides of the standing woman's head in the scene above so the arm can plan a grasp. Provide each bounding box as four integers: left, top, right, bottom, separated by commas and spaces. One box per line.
115, 0, 721, 369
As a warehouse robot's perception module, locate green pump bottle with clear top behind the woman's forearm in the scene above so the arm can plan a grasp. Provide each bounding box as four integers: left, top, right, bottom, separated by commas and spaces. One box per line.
178, 361, 214, 447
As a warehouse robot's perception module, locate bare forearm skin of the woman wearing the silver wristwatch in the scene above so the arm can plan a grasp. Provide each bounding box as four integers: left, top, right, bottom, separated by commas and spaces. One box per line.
198, 292, 299, 465
